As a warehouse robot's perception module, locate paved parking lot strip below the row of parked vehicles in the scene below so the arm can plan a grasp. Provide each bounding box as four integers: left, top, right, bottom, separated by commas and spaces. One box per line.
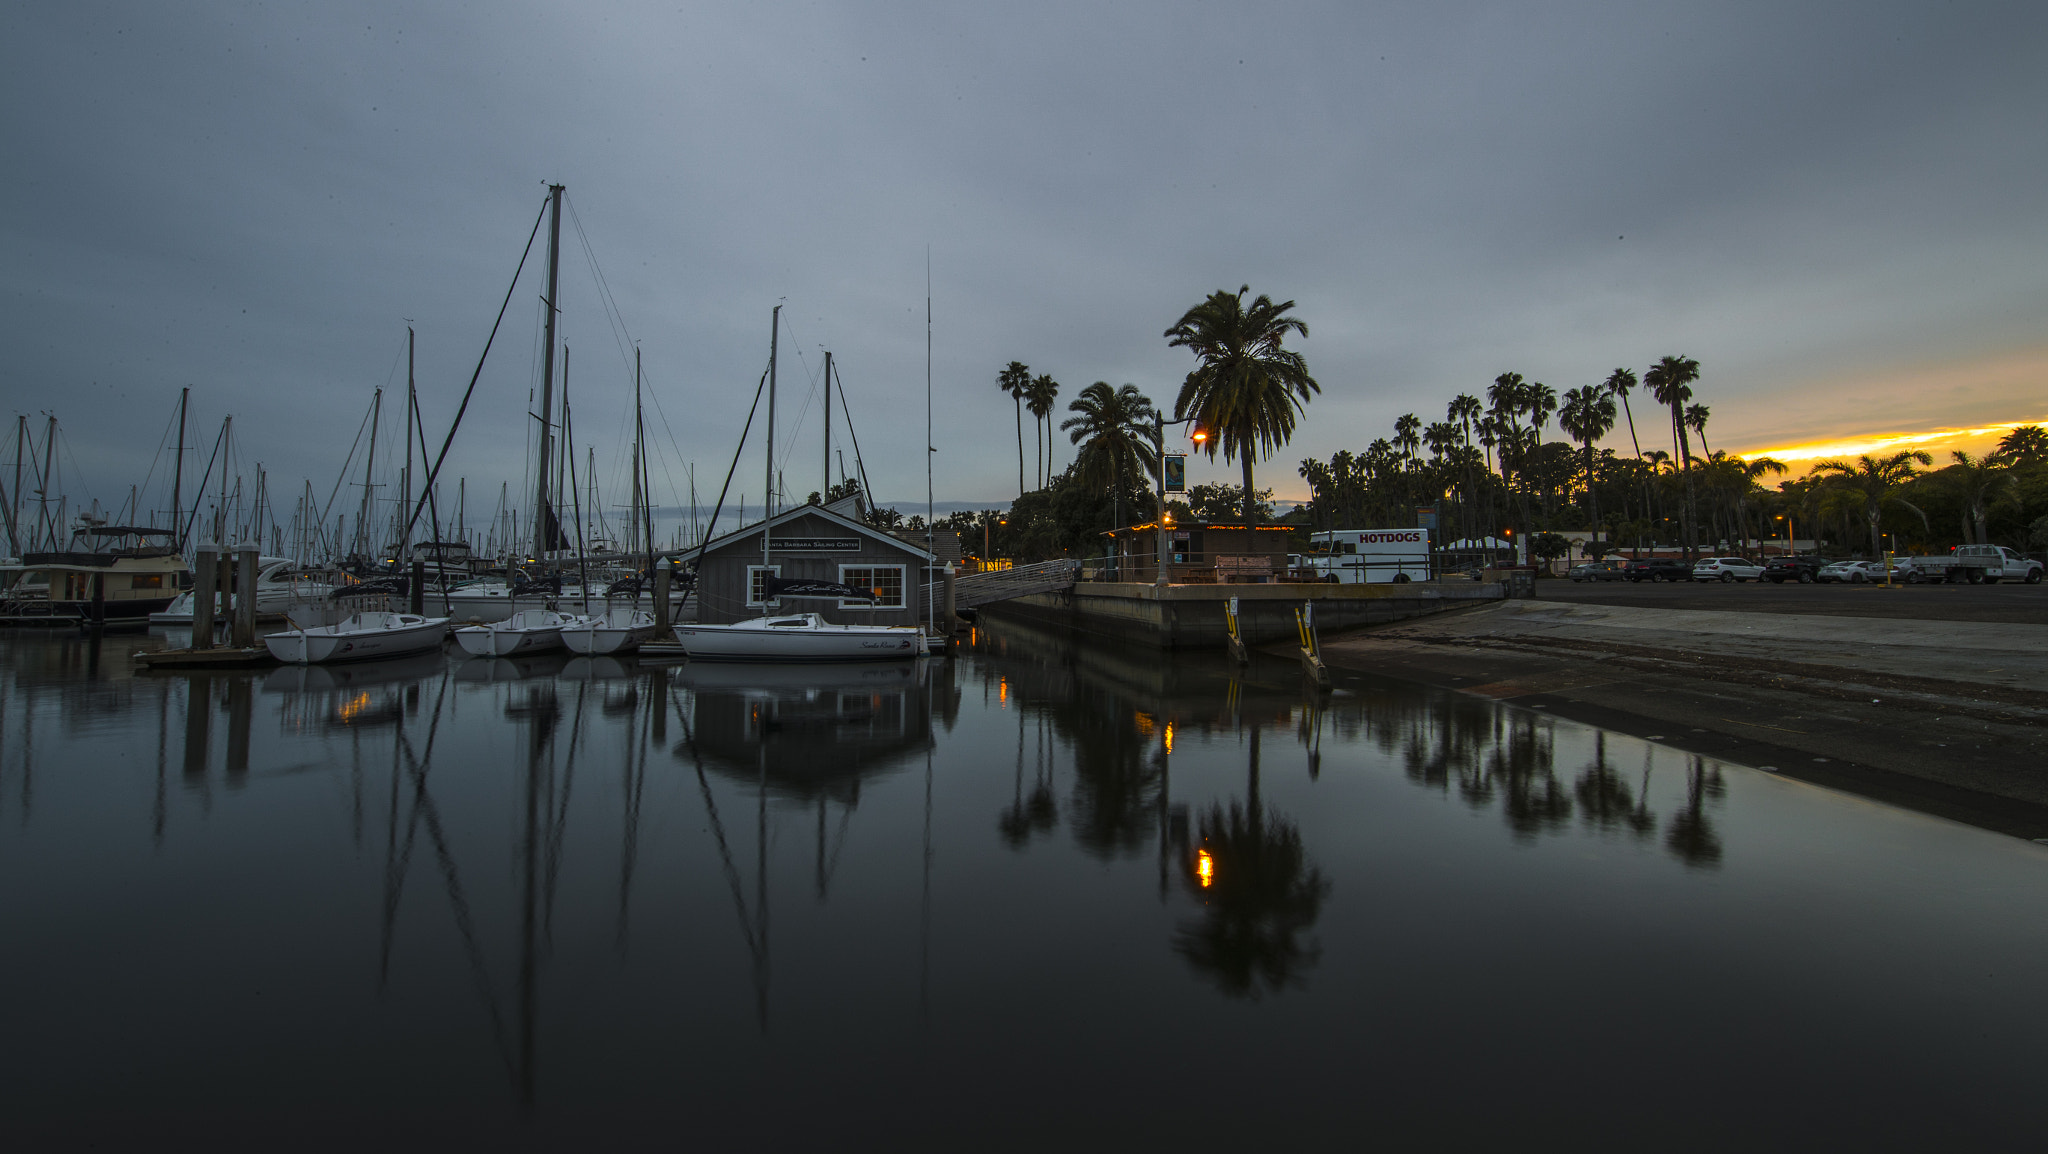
1536, 578, 2048, 625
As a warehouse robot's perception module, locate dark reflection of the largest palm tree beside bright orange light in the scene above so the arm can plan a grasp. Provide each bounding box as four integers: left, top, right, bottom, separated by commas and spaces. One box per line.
1174, 728, 1329, 998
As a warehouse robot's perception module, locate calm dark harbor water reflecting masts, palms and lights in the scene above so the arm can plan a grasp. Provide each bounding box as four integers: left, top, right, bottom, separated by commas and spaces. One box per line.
0, 631, 2048, 1150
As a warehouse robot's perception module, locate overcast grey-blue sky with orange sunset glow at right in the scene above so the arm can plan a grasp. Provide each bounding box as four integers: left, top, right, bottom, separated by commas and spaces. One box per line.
0, 0, 2048, 528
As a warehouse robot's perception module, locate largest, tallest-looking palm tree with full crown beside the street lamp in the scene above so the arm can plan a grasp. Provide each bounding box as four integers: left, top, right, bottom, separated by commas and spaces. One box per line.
1165, 285, 1323, 525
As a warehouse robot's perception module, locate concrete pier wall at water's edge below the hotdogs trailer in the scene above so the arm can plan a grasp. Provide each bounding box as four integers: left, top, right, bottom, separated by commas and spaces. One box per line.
981, 580, 1505, 650
